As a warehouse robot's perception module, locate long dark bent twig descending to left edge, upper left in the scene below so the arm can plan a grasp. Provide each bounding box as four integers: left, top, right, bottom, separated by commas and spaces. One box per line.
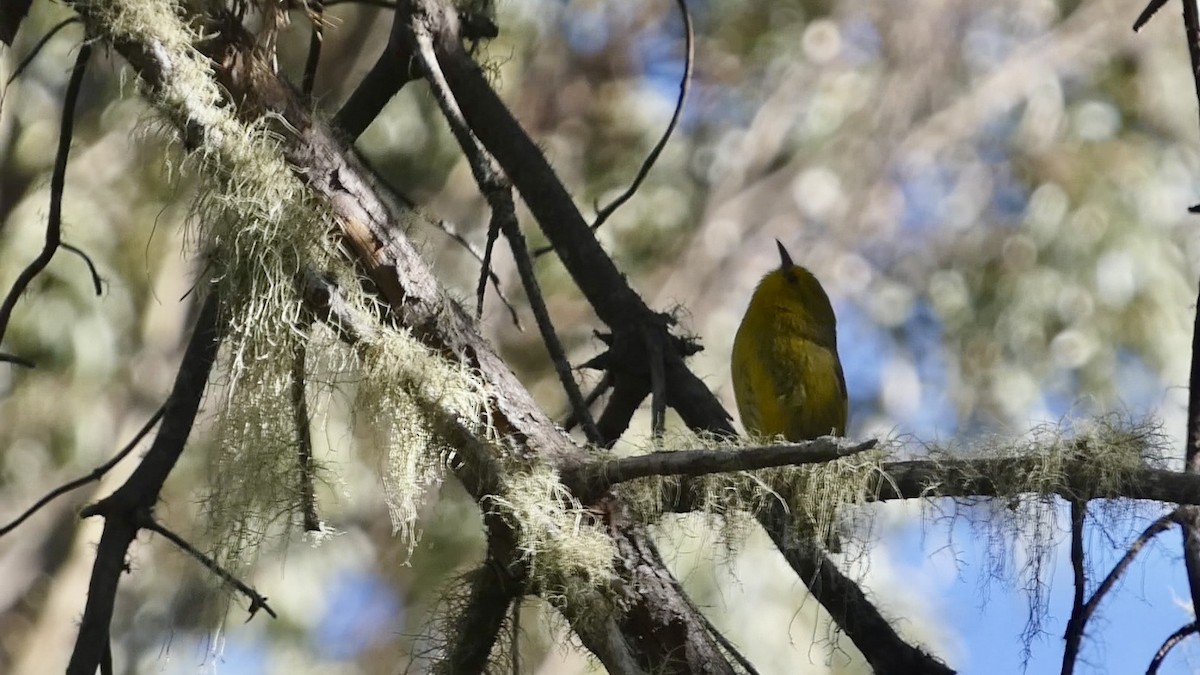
0, 42, 91, 348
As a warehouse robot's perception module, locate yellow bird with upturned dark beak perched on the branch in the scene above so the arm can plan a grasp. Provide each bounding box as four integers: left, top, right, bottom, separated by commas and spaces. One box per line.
732, 239, 847, 441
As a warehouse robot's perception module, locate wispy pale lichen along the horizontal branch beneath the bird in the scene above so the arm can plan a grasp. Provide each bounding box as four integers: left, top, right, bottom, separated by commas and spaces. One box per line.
618, 414, 1170, 550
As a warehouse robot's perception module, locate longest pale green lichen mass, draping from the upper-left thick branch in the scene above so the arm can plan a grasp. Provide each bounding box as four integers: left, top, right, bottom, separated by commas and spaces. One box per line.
80, 0, 336, 568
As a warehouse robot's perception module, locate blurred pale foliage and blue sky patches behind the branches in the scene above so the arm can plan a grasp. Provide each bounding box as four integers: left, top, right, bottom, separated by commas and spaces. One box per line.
0, 0, 1200, 674
